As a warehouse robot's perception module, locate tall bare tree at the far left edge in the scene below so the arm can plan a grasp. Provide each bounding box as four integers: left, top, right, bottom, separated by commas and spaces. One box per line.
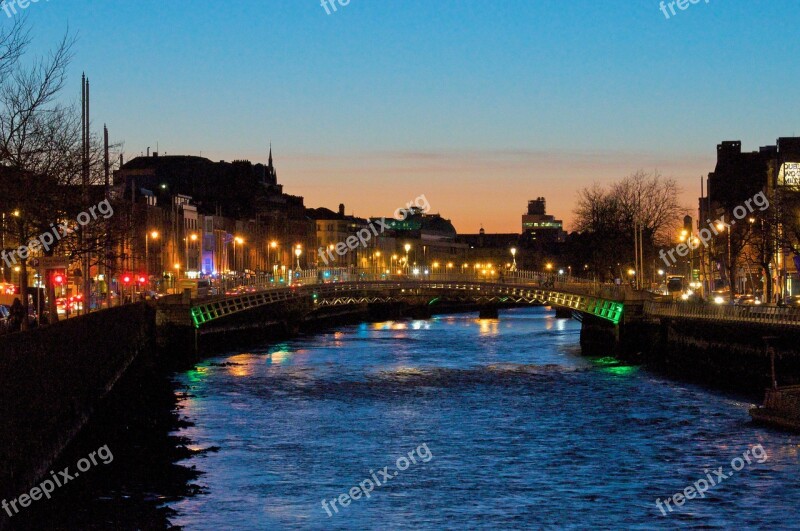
0, 19, 80, 326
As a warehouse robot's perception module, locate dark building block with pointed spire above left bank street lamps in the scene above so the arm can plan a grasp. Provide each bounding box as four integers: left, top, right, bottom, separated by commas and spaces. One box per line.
114, 148, 317, 277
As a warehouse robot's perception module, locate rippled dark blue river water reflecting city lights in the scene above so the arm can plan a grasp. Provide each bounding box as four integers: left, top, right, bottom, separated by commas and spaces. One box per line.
168, 308, 800, 530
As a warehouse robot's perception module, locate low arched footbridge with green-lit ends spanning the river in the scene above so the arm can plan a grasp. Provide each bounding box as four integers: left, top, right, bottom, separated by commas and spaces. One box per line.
190, 270, 635, 330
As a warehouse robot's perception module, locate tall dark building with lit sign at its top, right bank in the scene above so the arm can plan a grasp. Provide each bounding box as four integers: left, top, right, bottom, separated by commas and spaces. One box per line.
692, 138, 800, 301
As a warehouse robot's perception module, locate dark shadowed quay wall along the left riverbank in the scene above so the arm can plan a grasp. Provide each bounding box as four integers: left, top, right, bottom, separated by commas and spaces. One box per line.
0, 304, 155, 510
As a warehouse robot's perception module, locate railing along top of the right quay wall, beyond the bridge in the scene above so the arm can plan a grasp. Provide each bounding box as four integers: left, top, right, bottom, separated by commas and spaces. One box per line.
644, 301, 800, 326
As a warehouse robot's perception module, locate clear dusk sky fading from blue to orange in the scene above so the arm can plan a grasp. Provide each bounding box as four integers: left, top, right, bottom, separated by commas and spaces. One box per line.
10, 0, 800, 233
